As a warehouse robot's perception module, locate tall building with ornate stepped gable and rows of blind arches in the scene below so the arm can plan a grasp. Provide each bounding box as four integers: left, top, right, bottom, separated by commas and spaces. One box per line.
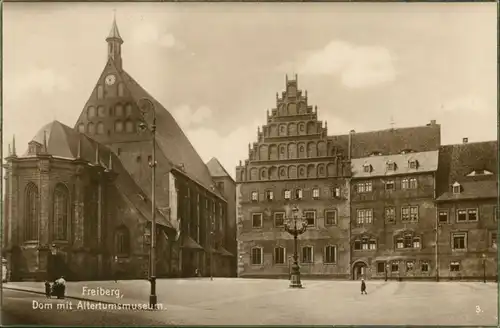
236, 77, 350, 278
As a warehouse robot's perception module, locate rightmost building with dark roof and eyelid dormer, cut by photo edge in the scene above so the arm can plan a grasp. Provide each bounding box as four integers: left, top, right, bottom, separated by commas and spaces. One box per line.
436, 138, 498, 279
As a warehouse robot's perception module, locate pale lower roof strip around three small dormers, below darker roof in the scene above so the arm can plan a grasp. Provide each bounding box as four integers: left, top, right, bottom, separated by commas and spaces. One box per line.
351, 150, 439, 178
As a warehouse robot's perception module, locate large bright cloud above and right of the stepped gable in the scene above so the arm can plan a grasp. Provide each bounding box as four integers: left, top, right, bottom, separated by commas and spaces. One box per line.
282, 41, 396, 88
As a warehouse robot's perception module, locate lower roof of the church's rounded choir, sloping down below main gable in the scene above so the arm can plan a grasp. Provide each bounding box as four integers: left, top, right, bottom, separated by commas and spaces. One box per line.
25, 121, 172, 227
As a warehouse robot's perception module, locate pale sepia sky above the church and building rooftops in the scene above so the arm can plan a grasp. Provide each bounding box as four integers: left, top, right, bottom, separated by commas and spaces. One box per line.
3, 2, 497, 177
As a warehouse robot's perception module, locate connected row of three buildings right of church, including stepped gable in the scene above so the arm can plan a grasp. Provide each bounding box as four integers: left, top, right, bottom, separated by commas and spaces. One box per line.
236, 78, 498, 280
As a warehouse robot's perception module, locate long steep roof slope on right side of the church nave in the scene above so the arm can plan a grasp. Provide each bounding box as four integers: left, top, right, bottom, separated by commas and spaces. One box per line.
121, 72, 223, 198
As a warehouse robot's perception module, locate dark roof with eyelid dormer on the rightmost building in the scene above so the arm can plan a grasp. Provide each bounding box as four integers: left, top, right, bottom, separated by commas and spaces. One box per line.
436, 141, 498, 197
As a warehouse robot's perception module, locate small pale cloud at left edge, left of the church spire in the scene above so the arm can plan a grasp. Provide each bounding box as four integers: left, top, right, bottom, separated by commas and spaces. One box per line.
5, 68, 71, 98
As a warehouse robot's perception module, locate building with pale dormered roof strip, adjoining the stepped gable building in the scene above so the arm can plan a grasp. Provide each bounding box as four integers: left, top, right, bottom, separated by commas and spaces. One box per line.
350, 121, 440, 279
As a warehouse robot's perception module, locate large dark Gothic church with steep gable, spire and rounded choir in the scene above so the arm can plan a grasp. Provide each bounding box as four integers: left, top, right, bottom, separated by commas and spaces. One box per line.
4, 16, 235, 280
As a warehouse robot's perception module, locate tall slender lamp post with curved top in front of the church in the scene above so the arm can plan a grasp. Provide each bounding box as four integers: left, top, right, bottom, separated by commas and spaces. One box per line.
137, 98, 157, 308
